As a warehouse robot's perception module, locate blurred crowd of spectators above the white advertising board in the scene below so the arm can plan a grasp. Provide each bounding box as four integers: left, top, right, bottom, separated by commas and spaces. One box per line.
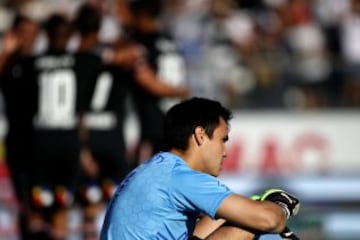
164, 0, 360, 110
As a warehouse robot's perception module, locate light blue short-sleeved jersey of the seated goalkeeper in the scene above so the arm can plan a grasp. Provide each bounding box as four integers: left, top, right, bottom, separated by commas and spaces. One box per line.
100, 152, 232, 240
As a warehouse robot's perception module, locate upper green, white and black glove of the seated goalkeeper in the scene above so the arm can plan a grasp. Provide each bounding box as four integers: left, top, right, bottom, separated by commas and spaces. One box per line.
260, 189, 300, 218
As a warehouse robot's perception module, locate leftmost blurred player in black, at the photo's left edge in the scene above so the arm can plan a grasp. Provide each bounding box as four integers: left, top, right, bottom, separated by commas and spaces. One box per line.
0, 14, 39, 239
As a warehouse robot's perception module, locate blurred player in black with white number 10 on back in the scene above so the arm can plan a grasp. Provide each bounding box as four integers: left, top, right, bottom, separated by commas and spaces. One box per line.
23, 14, 87, 240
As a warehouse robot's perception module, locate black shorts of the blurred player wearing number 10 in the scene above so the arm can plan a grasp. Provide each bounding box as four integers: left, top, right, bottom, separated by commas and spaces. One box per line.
28, 130, 80, 212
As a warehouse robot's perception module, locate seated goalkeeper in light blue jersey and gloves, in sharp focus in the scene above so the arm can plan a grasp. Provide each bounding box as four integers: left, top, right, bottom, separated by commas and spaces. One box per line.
100, 98, 299, 240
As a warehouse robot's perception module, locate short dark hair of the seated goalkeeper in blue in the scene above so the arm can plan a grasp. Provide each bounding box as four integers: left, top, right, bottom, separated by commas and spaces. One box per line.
165, 97, 232, 150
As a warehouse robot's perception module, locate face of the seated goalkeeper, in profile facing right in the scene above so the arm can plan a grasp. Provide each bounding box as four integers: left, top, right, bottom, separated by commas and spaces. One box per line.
202, 118, 229, 177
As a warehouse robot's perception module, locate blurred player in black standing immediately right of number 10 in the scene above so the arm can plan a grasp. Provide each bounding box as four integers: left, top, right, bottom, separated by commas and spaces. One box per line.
74, 3, 131, 239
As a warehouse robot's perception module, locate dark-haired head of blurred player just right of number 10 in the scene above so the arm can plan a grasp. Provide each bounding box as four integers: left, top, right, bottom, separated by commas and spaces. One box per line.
74, 3, 102, 36
